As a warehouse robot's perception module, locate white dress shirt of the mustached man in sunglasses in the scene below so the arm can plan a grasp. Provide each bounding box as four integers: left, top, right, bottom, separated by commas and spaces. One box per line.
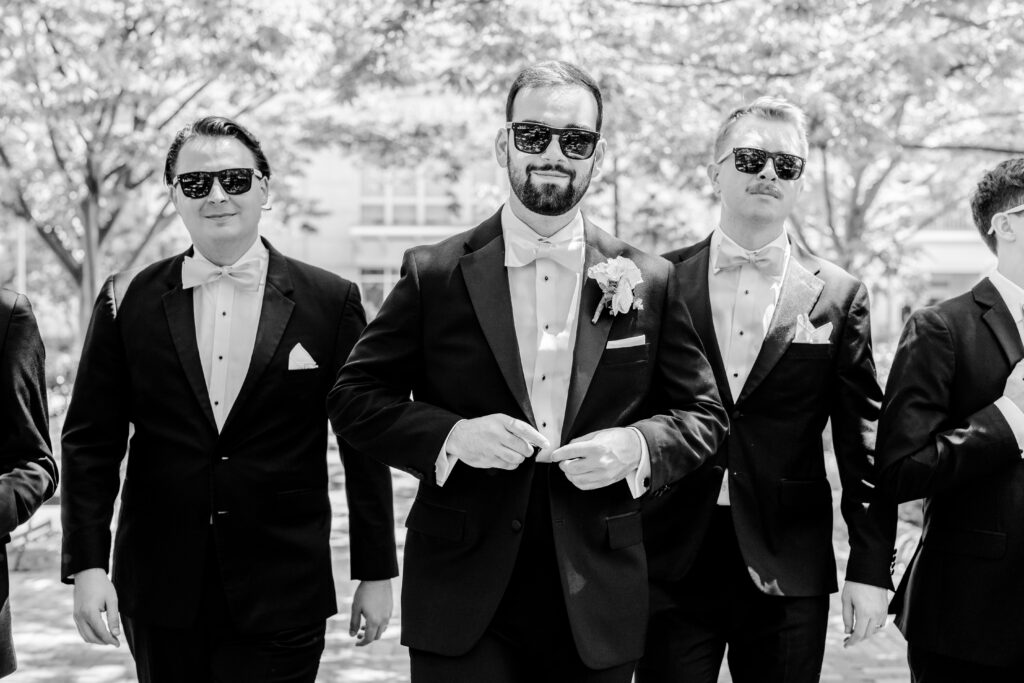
708, 228, 792, 505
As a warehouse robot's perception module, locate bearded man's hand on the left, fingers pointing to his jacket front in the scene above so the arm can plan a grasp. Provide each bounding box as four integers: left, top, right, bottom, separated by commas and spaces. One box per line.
446, 413, 550, 470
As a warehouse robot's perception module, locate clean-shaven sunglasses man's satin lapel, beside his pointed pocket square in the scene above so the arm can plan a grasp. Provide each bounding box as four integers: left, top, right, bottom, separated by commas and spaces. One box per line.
221, 248, 295, 434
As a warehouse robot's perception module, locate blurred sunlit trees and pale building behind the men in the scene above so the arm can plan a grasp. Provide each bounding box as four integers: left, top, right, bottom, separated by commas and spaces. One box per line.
0, 0, 1024, 679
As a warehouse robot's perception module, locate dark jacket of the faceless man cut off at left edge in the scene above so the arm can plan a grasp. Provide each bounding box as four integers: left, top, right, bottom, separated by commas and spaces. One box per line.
0, 290, 57, 676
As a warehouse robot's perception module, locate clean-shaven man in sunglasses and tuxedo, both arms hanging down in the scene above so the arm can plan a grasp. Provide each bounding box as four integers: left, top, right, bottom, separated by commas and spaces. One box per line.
61, 117, 397, 683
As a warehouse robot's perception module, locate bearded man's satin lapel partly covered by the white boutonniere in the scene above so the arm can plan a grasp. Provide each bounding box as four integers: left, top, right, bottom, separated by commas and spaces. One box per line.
562, 221, 617, 443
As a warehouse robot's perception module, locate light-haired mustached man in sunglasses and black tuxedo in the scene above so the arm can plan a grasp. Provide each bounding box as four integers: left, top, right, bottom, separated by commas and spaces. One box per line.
638, 97, 896, 683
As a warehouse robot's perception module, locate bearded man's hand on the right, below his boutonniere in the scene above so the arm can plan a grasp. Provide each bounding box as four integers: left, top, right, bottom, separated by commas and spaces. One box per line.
551, 427, 641, 490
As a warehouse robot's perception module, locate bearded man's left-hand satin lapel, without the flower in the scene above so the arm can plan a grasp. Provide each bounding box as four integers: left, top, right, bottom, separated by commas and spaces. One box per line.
459, 230, 537, 424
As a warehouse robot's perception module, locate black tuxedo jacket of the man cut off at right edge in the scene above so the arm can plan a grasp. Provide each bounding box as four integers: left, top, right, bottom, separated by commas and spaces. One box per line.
879, 279, 1024, 666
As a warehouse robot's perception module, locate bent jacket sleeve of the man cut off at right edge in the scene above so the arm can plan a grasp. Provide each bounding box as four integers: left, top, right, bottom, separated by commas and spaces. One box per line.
879, 308, 1021, 502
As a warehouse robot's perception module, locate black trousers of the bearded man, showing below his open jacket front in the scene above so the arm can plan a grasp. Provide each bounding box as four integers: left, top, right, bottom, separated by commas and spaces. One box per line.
410, 463, 636, 683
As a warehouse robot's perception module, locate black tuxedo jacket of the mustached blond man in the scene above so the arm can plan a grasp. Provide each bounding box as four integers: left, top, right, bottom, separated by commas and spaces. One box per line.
644, 238, 896, 596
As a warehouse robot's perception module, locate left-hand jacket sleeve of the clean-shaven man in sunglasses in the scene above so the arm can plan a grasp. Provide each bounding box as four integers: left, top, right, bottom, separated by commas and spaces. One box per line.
60, 276, 131, 584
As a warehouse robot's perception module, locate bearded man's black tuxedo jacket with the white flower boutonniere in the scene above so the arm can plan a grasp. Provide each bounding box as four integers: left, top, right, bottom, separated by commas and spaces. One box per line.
329, 209, 725, 668
